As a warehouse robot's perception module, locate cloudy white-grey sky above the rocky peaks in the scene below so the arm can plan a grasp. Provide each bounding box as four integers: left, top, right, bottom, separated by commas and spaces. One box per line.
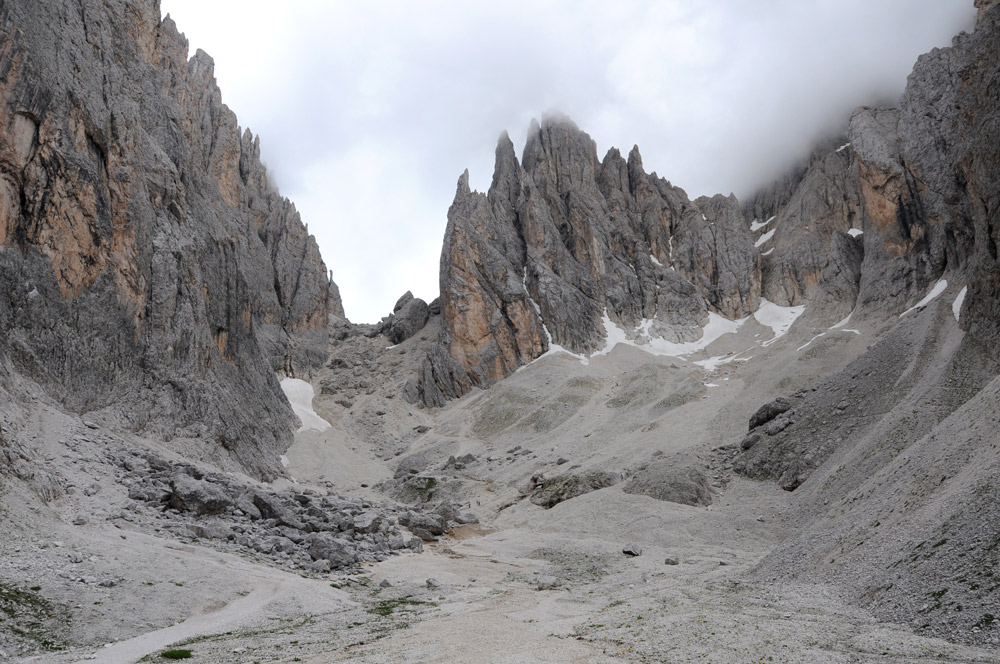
161, 0, 975, 322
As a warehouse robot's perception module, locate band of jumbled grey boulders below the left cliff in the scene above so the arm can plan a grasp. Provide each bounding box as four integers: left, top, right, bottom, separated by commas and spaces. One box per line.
124, 453, 475, 572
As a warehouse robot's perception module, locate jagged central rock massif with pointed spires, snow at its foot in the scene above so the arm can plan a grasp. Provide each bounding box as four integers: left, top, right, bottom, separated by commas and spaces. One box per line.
411, 118, 760, 405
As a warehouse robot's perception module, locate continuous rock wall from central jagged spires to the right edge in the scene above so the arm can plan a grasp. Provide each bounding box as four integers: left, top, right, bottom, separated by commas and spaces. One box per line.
409, 0, 1000, 405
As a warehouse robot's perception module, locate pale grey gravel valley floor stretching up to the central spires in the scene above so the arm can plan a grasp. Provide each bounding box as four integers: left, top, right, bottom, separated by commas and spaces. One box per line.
0, 302, 1000, 664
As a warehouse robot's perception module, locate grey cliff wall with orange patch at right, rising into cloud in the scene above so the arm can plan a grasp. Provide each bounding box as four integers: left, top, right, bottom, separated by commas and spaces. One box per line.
743, 2, 1000, 322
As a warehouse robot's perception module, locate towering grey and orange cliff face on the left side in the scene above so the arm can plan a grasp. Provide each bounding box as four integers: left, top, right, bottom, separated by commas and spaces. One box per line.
0, 0, 343, 475
